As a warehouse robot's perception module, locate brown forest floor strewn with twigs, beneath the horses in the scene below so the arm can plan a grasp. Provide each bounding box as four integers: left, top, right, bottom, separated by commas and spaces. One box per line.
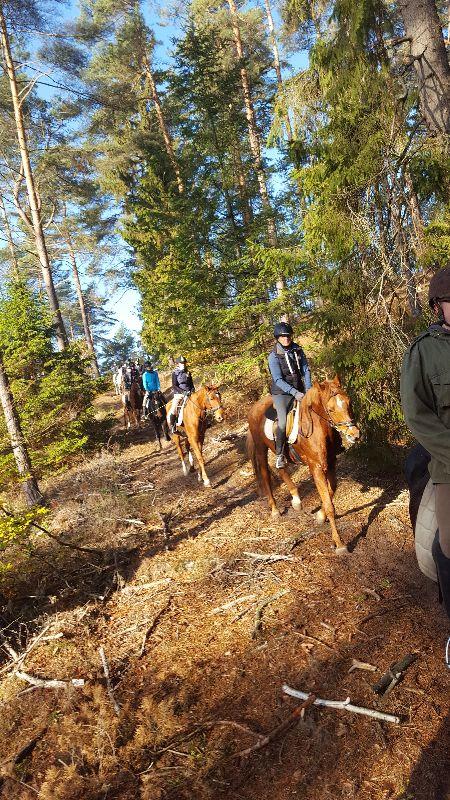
0, 395, 450, 800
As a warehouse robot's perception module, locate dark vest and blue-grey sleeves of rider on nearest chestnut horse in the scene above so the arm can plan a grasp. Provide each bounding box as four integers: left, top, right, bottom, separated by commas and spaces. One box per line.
269, 342, 311, 396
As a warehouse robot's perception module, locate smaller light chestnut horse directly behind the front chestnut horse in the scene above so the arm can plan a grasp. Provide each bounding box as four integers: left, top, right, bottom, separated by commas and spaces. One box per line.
166, 386, 224, 486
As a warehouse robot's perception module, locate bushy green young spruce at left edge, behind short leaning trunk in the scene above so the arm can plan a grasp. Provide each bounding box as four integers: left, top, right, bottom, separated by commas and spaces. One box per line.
0, 283, 95, 487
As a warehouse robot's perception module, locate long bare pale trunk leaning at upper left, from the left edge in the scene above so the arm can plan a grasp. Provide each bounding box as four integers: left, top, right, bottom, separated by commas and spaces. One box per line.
0, 3, 68, 350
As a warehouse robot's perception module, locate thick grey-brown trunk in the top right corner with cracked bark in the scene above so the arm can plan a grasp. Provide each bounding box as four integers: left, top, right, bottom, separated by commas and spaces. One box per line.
399, 0, 450, 134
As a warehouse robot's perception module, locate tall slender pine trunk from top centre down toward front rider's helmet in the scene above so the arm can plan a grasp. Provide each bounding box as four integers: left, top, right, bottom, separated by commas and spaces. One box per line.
228, 0, 283, 256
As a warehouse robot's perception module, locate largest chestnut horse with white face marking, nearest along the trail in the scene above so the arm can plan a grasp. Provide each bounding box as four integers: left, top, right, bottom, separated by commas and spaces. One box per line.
247, 375, 359, 552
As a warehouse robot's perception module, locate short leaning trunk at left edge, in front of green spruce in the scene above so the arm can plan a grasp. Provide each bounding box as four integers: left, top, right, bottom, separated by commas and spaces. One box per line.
0, 355, 44, 507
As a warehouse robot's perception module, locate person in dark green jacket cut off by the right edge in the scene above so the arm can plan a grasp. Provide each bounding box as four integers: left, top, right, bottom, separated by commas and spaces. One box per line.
400, 264, 450, 666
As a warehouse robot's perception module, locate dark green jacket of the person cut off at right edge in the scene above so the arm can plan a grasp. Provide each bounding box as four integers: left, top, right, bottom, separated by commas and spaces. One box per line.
400, 323, 450, 483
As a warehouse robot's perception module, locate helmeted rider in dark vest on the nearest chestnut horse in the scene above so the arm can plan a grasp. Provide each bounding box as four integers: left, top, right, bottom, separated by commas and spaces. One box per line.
269, 322, 311, 469
